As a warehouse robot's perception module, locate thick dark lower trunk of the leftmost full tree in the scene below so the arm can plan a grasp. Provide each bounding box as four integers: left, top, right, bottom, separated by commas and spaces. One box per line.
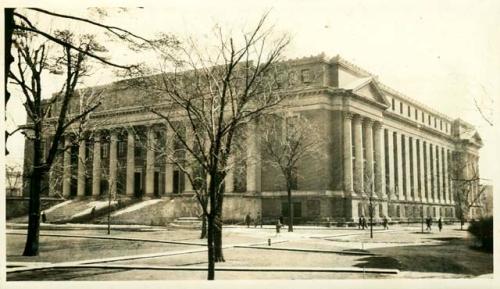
23, 137, 44, 256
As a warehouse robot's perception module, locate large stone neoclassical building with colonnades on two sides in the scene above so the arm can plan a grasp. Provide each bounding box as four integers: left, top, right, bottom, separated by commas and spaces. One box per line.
25, 55, 482, 221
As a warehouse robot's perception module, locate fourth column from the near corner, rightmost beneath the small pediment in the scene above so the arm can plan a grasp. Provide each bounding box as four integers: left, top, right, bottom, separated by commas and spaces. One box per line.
373, 122, 387, 198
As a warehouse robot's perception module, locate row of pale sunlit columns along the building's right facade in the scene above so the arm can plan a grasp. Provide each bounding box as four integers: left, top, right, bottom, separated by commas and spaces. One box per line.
343, 113, 453, 204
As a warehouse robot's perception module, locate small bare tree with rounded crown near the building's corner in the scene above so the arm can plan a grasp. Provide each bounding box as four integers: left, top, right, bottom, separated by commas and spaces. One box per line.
259, 113, 325, 232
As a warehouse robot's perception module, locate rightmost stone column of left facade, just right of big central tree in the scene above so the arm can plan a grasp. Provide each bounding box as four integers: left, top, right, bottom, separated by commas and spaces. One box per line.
247, 122, 261, 192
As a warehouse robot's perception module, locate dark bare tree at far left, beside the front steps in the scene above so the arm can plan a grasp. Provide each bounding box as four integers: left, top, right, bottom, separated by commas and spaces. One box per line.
9, 31, 113, 256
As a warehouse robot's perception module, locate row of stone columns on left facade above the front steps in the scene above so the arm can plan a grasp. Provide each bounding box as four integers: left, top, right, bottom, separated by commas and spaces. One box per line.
58, 123, 261, 196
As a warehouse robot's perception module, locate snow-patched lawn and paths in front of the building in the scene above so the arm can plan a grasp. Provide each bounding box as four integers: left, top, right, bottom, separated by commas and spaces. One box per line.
7, 226, 493, 280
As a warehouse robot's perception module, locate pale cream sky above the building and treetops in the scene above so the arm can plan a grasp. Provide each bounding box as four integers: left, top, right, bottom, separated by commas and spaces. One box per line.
7, 0, 500, 187
